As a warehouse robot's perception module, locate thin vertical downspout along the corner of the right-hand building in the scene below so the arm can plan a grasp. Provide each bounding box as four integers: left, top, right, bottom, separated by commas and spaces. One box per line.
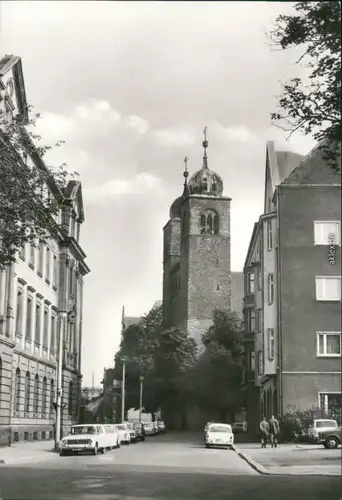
276, 186, 283, 417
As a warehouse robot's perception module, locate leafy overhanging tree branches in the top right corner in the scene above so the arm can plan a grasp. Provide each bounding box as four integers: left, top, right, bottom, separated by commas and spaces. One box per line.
269, 0, 342, 173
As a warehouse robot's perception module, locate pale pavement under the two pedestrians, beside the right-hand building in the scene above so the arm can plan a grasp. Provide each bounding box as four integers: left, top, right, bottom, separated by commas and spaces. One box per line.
235, 443, 342, 476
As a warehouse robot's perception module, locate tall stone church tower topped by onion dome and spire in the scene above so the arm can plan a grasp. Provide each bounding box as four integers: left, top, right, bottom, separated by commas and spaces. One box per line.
163, 128, 231, 344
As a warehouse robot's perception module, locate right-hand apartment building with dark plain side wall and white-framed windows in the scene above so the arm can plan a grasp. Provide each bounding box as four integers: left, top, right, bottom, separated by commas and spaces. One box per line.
243, 143, 341, 430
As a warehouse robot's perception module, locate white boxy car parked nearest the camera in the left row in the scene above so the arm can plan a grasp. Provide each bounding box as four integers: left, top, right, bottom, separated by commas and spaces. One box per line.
59, 424, 108, 456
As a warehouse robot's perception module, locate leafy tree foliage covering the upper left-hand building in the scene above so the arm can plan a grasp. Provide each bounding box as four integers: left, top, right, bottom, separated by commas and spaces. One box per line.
0, 106, 77, 269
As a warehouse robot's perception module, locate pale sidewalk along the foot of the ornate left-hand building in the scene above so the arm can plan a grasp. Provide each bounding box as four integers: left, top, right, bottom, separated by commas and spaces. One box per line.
0, 440, 55, 465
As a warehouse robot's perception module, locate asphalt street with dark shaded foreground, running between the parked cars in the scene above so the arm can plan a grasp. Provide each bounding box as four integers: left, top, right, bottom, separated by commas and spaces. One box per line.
0, 434, 341, 500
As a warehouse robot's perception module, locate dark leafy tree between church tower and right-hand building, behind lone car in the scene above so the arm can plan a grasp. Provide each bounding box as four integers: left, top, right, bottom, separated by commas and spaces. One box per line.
194, 310, 243, 421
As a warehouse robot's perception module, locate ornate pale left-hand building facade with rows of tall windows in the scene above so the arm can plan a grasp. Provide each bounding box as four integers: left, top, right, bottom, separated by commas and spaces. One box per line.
0, 56, 89, 445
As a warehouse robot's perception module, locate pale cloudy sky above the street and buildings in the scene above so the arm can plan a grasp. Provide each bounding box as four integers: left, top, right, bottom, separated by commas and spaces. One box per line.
0, 1, 314, 386
